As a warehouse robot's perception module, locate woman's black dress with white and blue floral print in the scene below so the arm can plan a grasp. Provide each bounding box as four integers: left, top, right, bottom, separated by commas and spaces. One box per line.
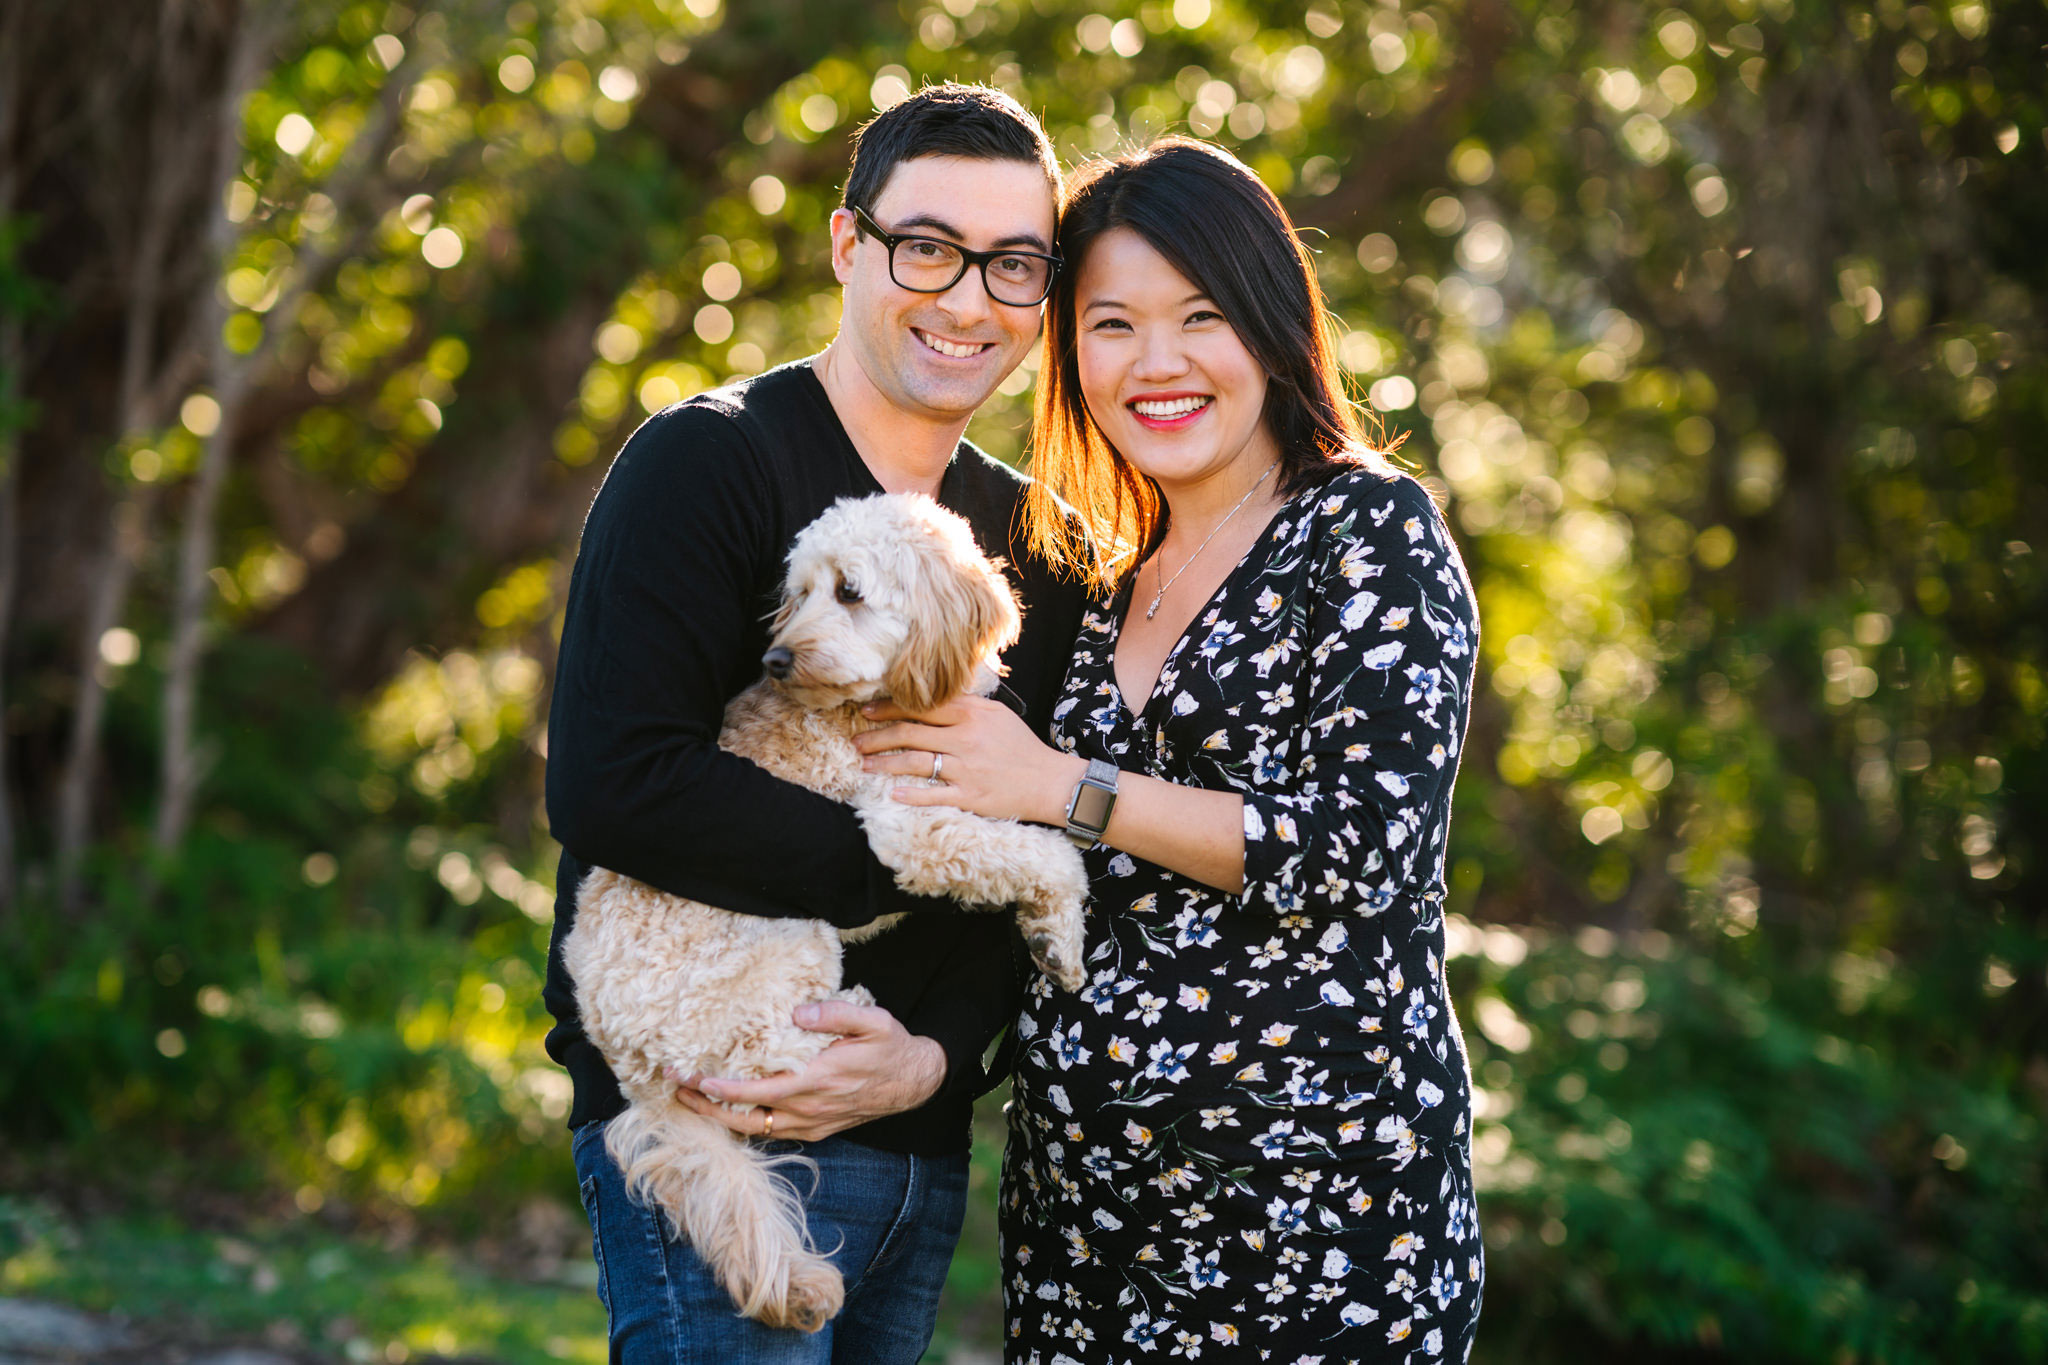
1001, 469, 1481, 1365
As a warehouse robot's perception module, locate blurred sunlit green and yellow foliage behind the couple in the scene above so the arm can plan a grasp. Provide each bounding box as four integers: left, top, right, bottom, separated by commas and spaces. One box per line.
0, 0, 2048, 1363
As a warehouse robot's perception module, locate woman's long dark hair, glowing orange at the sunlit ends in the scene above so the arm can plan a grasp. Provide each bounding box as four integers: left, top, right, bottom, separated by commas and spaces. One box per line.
1026, 137, 1393, 587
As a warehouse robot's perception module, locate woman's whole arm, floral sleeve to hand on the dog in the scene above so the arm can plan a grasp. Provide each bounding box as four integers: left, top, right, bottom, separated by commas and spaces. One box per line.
856, 479, 1479, 913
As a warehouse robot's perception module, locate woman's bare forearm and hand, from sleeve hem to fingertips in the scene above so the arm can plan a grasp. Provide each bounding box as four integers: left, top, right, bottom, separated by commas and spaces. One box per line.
854, 696, 1245, 894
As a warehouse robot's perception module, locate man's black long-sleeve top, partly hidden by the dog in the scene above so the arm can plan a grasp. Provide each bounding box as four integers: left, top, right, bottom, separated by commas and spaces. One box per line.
545, 360, 1081, 1154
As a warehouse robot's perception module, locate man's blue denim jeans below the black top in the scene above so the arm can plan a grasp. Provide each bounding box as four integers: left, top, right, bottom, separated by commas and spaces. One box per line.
571, 1124, 967, 1365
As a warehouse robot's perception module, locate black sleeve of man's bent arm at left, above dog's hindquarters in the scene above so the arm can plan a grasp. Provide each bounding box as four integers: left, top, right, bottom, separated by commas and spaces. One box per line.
547, 407, 932, 925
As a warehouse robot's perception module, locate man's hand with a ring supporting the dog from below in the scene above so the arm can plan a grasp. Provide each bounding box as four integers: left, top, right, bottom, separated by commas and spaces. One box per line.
670, 1001, 946, 1142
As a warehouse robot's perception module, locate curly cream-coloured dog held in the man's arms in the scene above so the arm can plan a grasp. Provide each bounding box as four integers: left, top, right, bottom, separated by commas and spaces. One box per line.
563, 493, 1087, 1332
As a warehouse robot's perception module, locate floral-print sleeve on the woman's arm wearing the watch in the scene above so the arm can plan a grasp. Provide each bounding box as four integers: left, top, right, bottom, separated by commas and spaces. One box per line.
1243, 477, 1479, 915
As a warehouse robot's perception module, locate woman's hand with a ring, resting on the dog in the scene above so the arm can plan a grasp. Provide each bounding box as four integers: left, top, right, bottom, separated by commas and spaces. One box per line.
854, 696, 1087, 825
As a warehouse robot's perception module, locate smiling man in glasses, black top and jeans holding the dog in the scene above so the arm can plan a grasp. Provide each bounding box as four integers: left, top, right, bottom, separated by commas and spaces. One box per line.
547, 86, 1081, 1365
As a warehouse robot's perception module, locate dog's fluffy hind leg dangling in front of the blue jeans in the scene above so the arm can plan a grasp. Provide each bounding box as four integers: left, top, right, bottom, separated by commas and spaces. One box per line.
604, 1101, 846, 1332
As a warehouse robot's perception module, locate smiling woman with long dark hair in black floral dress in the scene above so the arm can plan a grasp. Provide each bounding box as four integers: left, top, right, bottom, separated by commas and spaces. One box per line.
864, 139, 1481, 1365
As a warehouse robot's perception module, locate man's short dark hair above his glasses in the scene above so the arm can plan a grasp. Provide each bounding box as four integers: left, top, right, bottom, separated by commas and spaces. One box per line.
844, 82, 1059, 209
